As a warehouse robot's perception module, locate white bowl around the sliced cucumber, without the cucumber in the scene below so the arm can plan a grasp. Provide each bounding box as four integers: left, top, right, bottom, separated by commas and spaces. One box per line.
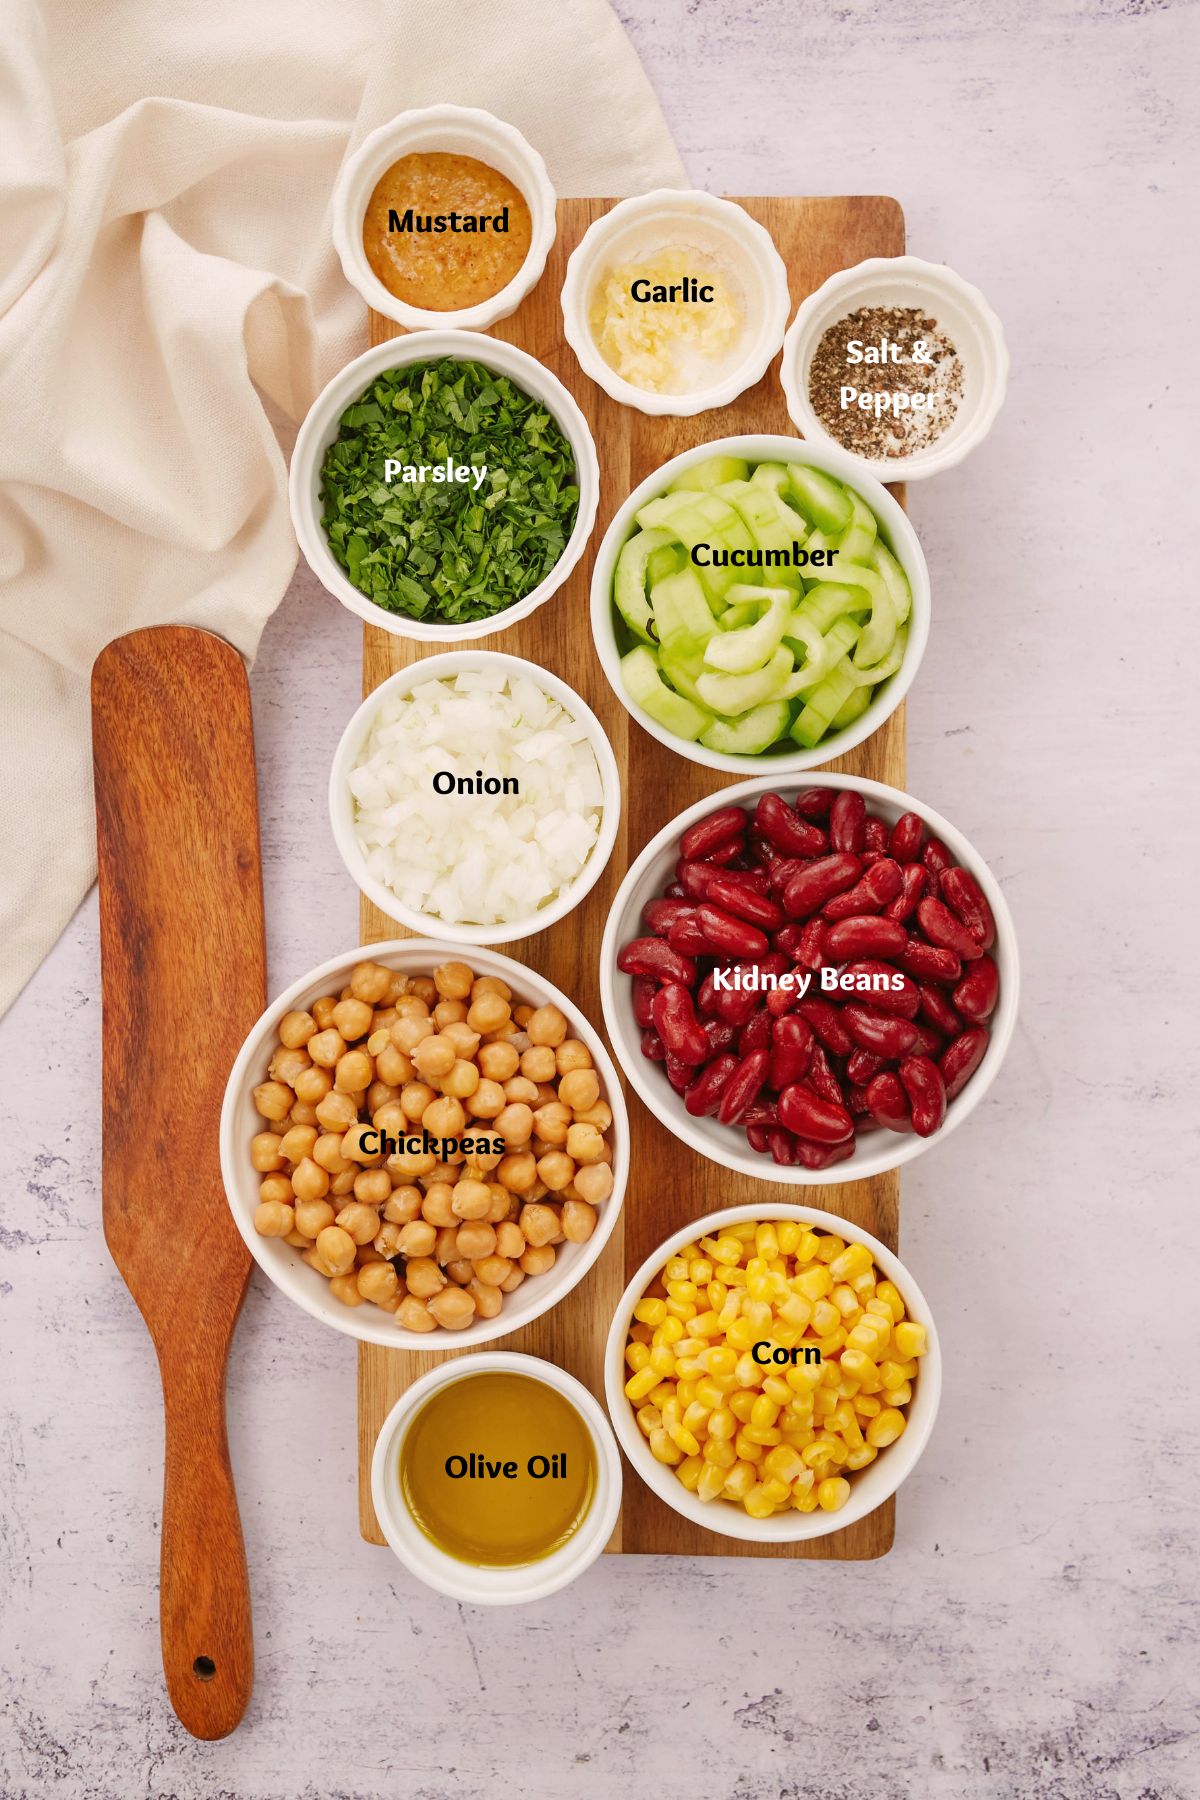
592, 436, 930, 778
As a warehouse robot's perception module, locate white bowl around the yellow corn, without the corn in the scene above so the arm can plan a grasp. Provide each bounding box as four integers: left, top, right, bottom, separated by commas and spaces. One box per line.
604, 1201, 941, 1544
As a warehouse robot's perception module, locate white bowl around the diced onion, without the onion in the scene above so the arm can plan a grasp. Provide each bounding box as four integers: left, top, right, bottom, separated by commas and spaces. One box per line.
329, 650, 621, 943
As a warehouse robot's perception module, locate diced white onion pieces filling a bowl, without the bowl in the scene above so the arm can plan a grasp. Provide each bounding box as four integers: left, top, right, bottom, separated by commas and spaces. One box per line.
349, 668, 604, 925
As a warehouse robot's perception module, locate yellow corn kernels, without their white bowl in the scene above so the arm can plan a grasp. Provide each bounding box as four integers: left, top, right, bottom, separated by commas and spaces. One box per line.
624, 1219, 927, 1519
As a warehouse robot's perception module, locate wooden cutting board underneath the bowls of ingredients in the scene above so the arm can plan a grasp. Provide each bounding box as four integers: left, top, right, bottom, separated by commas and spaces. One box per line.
358, 196, 905, 1559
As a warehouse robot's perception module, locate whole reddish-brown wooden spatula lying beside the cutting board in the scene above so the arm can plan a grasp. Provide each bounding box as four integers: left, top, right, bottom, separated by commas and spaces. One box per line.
92, 626, 266, 1737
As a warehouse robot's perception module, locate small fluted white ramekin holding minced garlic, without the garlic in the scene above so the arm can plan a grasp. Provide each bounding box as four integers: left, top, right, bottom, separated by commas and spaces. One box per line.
563, 187, 792, 418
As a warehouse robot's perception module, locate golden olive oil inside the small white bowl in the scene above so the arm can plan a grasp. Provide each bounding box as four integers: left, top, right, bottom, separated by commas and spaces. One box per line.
399, 1370, 596, 1568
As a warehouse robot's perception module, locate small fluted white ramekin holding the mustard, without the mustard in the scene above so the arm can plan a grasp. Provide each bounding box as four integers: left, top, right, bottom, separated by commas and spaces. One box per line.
333, 106, 558, 331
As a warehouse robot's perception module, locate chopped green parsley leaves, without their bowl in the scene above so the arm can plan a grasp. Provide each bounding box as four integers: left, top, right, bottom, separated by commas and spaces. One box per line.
320, 356, 579, 623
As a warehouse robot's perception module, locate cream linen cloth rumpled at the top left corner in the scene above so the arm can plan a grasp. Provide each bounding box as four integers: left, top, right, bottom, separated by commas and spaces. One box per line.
0, 0, 685, 1012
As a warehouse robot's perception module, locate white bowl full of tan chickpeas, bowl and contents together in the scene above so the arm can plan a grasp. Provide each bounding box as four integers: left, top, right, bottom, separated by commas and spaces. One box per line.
221, 940, 628, 1348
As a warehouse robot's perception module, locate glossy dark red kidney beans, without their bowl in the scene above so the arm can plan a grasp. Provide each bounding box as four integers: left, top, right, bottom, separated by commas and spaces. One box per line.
617, 785, 1000, 1174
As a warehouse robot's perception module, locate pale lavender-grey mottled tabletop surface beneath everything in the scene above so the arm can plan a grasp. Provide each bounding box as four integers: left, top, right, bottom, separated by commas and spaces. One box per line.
0, 0, 1200, 1800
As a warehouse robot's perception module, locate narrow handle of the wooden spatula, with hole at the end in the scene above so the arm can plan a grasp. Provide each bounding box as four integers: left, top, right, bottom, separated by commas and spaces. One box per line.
160, 1345, 254, 1737
